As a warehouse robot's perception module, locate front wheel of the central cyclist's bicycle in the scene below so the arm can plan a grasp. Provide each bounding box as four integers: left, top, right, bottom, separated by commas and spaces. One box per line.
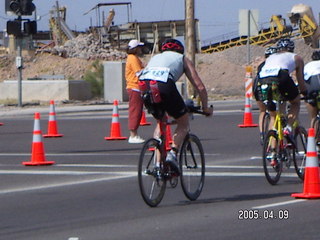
179, 134, 205, 201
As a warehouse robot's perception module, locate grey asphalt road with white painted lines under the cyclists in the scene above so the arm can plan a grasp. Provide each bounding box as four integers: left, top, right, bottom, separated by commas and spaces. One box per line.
0, 103, 320, 240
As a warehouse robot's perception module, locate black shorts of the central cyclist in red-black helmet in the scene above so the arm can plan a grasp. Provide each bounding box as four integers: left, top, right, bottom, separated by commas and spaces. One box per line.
158, 79, 187, 119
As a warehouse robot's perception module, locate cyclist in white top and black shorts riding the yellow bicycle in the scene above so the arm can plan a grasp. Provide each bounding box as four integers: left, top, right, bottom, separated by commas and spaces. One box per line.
259, 39, 306, 137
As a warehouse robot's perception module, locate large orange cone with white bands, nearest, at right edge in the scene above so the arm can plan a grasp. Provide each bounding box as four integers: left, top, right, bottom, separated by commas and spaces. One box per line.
291, 128, 320, 198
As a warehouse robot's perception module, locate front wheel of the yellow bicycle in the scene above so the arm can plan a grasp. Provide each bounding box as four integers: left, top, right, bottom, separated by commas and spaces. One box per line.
293, 126, 308, 180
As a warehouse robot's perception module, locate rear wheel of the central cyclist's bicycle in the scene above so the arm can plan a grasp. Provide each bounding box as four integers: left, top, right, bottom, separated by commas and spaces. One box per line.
138, 138, 166, 207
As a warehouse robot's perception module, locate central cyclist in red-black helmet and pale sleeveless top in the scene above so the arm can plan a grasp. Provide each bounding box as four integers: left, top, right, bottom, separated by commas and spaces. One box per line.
139, 39, 213, 174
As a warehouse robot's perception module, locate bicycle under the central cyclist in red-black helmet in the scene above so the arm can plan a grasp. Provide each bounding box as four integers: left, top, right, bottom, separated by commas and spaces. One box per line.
138, 101, 210, 207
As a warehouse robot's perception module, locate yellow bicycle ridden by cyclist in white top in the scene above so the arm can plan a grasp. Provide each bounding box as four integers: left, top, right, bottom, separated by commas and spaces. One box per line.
262, 82, 308, 185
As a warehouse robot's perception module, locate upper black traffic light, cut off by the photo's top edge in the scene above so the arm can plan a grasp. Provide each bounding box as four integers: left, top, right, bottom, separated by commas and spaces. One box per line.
6, 0, 36, 16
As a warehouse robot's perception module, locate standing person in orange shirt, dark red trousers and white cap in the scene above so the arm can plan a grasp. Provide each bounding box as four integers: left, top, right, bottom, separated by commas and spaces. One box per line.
125, 39, 144, 143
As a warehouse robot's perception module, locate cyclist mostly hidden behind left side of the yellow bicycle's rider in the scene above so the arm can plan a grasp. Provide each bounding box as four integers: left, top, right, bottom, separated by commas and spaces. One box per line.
252, 47, 278, 145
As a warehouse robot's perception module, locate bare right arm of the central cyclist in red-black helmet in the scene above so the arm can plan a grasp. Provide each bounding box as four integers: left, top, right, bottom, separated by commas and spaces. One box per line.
183, 57, 213, 114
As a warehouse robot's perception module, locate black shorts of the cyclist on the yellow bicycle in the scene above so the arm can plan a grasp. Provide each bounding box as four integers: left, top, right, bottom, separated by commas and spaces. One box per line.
253, 70, 299, 101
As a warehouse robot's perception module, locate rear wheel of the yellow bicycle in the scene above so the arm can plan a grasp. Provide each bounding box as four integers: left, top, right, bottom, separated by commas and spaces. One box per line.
262, 130, 282, 185
